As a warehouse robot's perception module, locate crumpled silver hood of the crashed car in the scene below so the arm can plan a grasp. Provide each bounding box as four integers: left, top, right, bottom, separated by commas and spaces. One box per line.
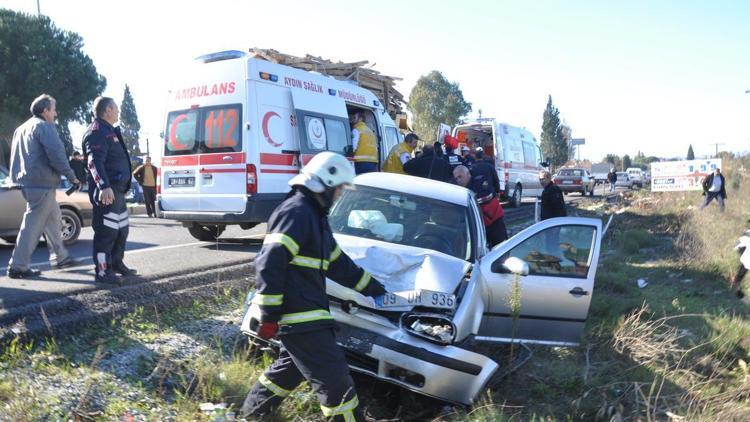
327, 234, 471, 302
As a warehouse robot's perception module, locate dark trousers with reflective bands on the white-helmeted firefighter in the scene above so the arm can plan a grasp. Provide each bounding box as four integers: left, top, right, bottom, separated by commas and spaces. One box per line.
240, 328, 364, 422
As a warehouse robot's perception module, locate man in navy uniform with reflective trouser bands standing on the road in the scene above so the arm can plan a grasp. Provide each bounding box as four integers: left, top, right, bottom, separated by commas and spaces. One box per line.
83, 97, 136, 283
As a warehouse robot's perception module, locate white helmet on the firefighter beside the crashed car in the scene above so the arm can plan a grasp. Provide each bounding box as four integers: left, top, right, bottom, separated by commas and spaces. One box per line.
289, 151, 354, 193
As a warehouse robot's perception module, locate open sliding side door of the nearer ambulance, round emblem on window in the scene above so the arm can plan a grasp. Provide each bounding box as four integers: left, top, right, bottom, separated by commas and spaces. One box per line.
292, 90, 352, 165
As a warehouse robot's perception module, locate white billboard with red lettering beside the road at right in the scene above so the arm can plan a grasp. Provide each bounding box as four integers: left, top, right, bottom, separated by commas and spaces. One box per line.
651, 158, 721, 192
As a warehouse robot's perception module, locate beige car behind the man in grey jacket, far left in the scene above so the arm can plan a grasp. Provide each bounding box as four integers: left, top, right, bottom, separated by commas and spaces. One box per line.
0, 166, 93, 245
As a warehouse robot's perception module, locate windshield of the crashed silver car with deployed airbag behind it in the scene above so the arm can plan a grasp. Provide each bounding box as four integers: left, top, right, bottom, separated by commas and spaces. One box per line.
329, 186, 472, 260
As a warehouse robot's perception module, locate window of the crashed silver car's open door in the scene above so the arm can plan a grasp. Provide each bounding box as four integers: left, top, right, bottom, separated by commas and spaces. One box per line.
492, 225, 596, 278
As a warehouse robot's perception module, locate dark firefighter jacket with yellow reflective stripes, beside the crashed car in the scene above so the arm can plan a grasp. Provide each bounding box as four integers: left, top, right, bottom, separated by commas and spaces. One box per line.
253, 190, 385, 334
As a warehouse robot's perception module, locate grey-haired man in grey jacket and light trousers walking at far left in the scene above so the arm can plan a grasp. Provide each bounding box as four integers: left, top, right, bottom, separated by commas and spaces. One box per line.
8, 94, 80, 278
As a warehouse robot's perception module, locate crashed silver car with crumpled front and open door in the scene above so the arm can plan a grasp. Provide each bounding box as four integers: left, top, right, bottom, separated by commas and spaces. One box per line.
241, 173, 602, 404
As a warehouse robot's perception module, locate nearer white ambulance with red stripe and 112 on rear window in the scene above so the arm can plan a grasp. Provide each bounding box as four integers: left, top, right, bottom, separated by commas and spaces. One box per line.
157, 50, 406, 240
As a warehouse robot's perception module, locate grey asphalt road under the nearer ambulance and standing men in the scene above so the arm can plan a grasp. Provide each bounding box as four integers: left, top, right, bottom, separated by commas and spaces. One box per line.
0, 183, 624, 318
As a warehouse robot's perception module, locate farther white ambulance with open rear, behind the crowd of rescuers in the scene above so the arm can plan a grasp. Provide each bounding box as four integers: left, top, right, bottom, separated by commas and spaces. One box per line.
453, 119, 549, 207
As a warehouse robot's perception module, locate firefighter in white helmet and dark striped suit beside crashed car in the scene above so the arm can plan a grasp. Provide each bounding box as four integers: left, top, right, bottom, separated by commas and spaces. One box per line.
241, 152, 385, 421
